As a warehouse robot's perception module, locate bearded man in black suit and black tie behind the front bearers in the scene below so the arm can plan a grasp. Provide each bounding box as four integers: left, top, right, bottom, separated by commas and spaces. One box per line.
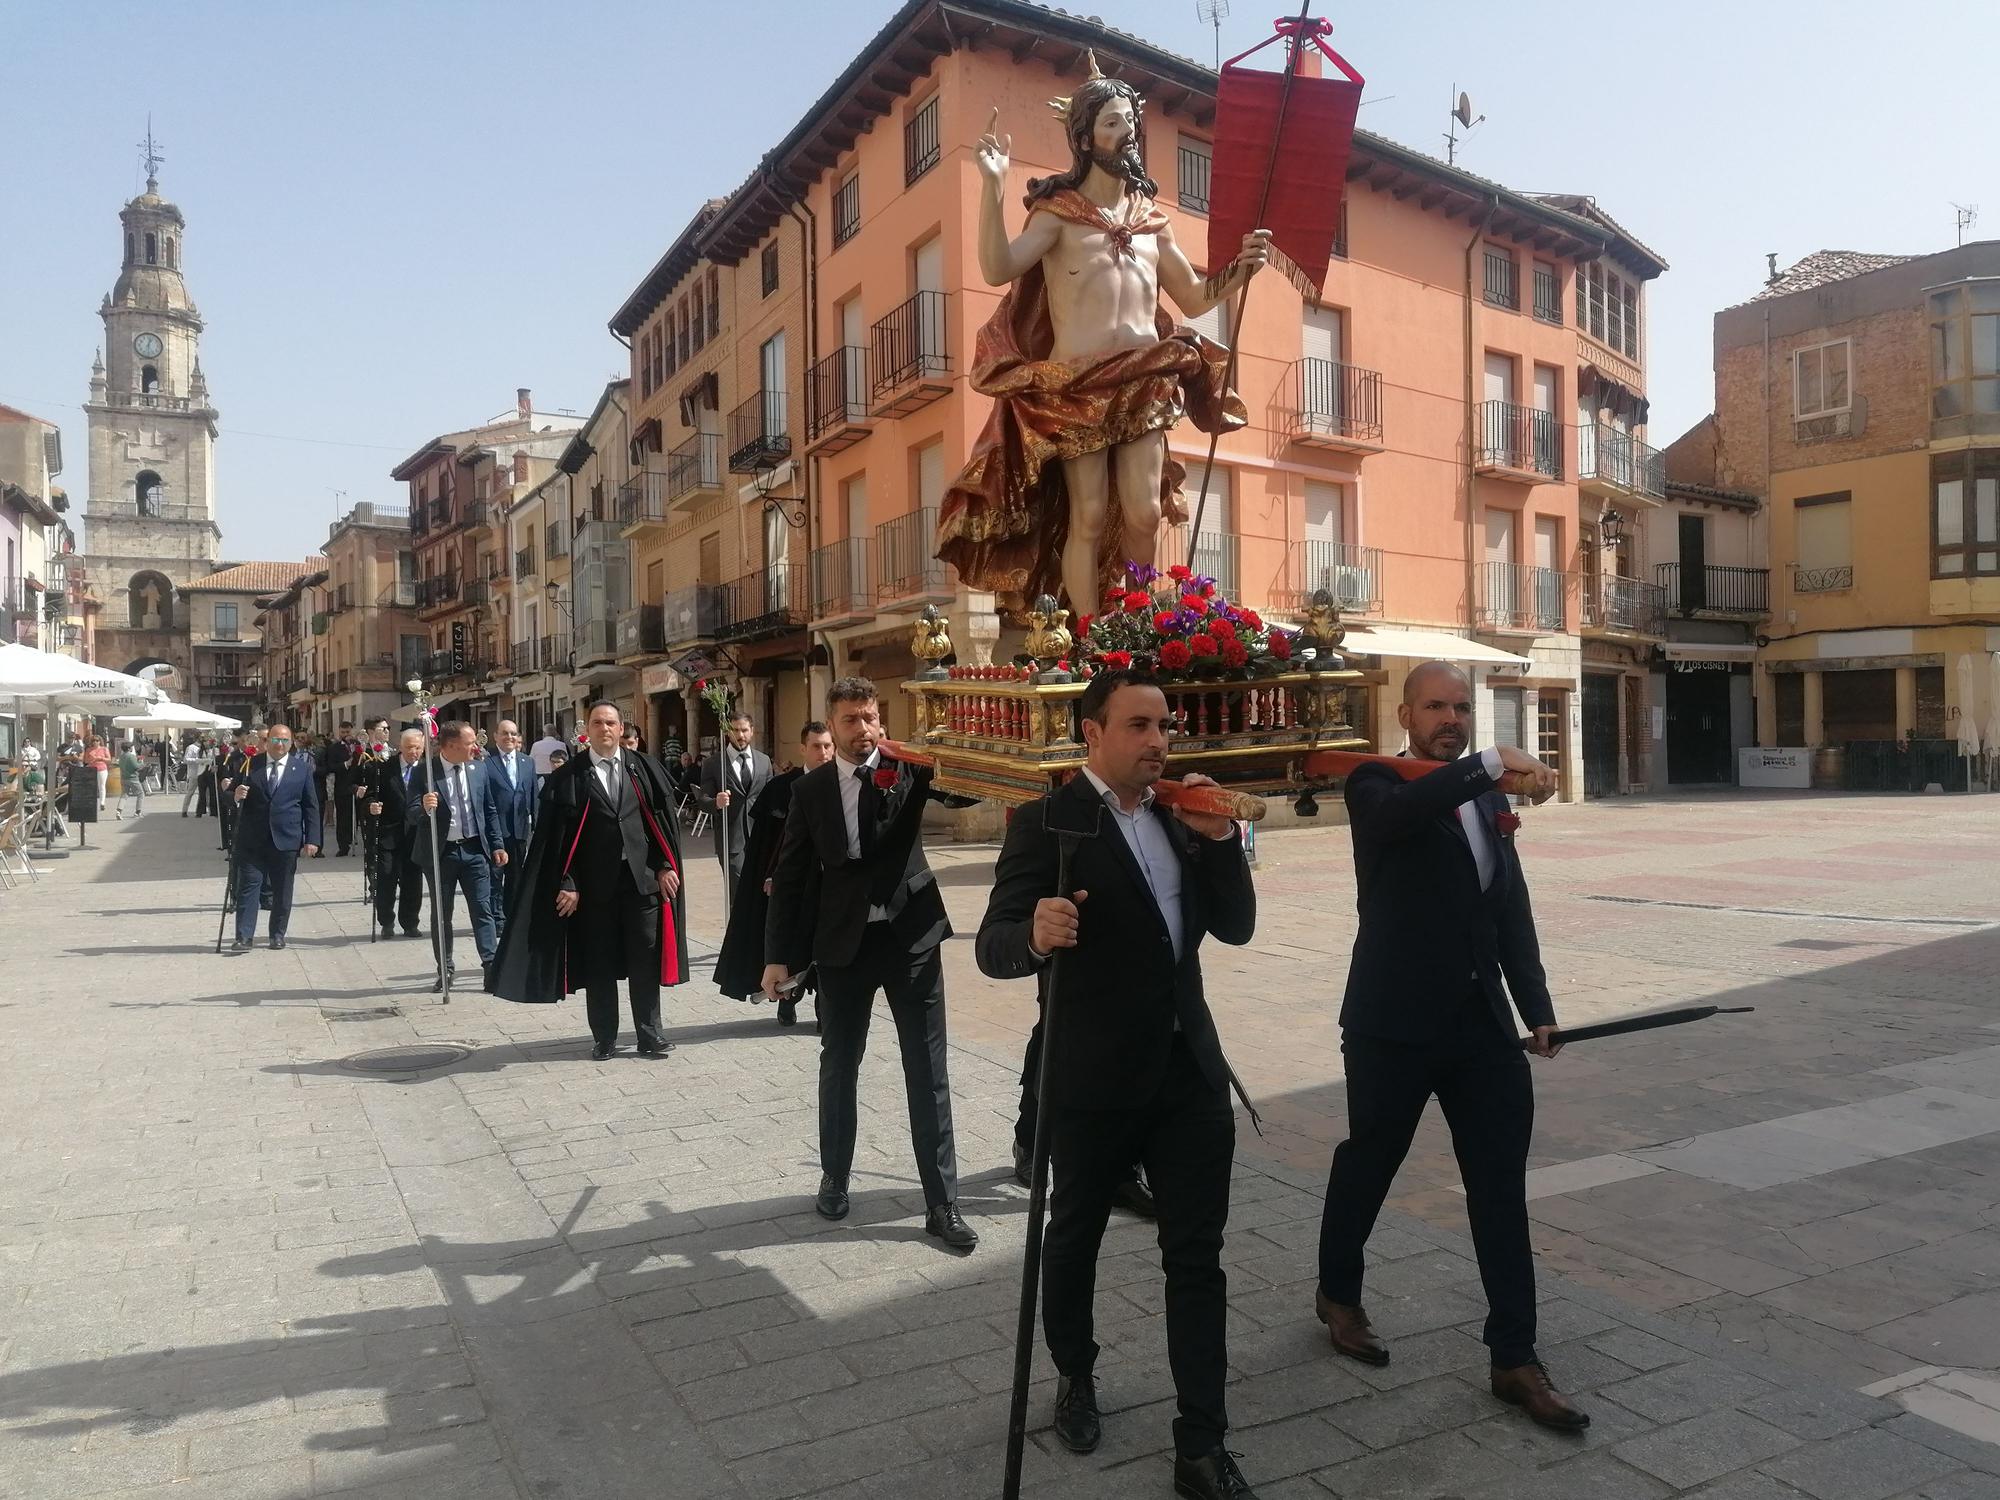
764, 678, 980, 1250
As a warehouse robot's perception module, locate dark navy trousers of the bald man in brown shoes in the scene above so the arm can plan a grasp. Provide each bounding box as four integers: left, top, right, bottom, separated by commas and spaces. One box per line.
1320, 1012, 1534, 1370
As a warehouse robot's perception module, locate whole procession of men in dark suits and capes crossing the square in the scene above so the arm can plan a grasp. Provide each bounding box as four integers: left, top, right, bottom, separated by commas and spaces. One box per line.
129, 662, 1590, 1500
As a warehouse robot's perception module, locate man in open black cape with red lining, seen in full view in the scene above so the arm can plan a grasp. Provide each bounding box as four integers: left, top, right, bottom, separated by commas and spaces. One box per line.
488, 704, 688, 1060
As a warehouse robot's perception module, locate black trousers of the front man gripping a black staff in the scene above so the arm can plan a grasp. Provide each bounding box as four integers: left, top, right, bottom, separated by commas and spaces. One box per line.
1042, 1036, 1236, 1458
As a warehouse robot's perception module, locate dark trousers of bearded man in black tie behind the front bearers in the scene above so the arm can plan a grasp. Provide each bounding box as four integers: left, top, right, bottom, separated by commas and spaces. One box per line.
818, 922, 958, 1208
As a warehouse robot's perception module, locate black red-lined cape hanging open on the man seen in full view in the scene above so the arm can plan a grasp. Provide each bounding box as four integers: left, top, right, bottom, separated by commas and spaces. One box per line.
486, 752, 688, 1004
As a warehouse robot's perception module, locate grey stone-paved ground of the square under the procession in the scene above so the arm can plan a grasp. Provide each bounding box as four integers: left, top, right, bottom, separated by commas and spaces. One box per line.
0, 794, 2000, 1500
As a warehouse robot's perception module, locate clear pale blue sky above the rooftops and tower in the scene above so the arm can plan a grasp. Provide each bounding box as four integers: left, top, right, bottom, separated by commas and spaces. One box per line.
0, 0, 2000, 558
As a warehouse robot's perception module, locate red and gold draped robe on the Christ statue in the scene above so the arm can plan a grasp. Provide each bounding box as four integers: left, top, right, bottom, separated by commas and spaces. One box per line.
938, 188, 1250, 614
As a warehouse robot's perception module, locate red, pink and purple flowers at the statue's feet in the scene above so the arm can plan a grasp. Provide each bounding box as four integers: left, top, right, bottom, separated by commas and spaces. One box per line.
1074, 562, 1296, 682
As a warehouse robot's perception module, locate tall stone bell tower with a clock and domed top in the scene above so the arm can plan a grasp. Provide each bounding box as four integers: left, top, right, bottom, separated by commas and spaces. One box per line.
82, 122, 222, 646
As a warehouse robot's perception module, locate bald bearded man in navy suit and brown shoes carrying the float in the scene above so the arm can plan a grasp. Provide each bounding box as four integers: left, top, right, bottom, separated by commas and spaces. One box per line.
1314, 662, 1590, 1432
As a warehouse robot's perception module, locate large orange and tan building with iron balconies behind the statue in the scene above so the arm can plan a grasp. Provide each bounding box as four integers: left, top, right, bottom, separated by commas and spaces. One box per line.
612, 0, 1664, 798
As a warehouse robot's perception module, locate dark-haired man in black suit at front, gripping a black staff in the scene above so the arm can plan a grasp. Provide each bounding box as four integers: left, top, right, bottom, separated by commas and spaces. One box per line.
976, 670, 1256, 1500
